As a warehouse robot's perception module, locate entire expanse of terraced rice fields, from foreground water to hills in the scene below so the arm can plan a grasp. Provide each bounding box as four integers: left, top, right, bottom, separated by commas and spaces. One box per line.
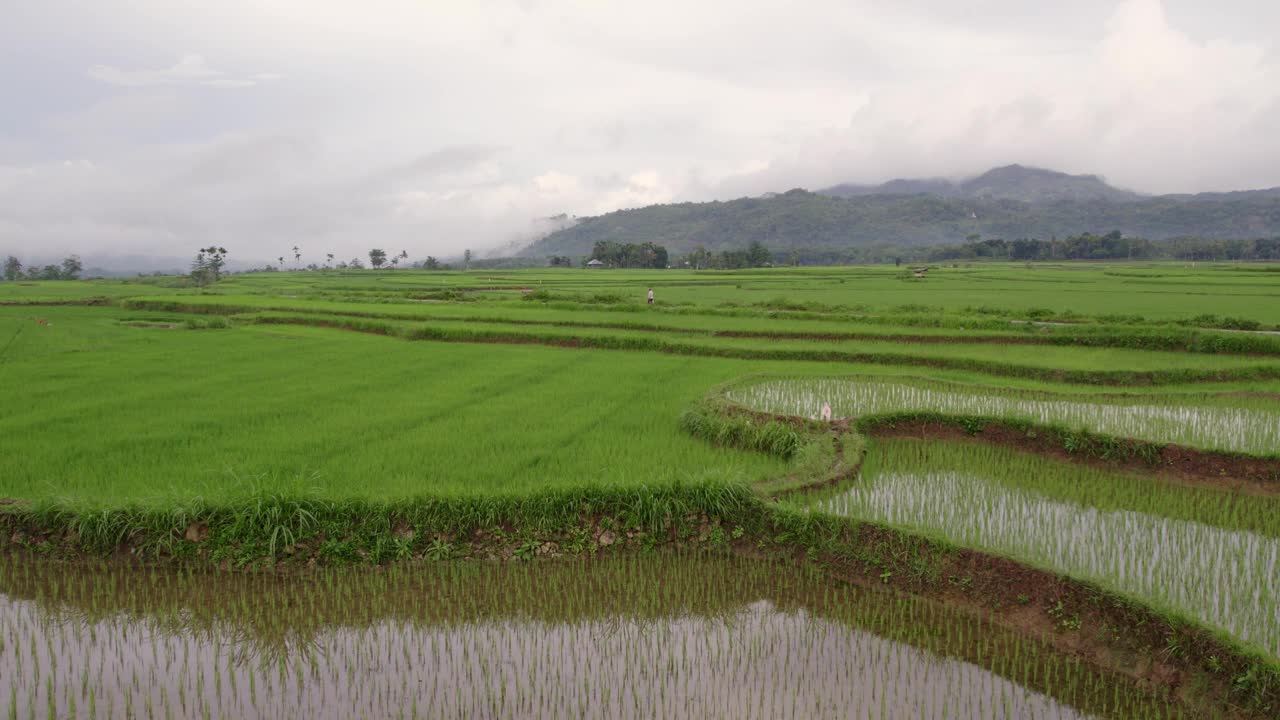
0, 265, 1280, 719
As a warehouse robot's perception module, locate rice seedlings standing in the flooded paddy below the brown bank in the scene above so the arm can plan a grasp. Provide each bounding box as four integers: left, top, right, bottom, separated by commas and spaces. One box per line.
817, 446, 1280, 657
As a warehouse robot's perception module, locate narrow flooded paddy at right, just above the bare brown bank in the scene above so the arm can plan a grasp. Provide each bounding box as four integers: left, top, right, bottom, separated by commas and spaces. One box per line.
727, 378, 1280, 455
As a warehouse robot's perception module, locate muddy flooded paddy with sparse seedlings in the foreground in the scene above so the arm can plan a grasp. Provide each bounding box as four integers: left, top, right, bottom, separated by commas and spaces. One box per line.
0, 555, 1169, 719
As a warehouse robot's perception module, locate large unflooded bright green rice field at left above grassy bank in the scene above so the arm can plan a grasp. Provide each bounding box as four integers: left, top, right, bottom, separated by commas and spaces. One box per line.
0, 309, 781, 505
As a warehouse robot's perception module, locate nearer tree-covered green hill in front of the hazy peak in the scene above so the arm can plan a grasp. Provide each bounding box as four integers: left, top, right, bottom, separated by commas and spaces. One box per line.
524, 175, 1280, 258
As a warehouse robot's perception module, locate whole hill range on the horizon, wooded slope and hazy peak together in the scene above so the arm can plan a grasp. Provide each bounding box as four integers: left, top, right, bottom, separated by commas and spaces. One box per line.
521, 165, 1280, 256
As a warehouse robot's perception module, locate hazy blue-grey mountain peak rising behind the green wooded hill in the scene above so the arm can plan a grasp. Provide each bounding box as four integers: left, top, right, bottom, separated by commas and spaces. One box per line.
818, 165, 1142, 202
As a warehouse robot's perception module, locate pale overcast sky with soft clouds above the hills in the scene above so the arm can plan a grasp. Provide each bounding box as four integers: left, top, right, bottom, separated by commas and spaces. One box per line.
0, 0, 1280, 263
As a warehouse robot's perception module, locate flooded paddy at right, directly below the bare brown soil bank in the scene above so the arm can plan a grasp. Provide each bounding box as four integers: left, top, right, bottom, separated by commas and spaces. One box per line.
819, 441, 1280, 656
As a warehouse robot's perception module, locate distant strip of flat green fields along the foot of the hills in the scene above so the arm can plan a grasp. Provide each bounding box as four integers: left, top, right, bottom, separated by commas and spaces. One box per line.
10, 263, 1280, 323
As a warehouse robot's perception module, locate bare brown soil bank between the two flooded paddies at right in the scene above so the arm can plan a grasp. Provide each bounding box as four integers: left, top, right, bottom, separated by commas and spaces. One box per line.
870, 421, 1280, 497
